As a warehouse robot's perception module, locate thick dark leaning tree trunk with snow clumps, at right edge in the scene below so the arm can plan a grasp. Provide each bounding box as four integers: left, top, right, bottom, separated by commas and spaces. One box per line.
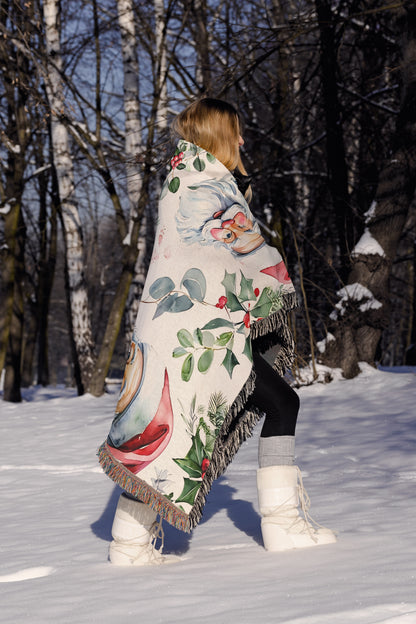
322, 2, 416, 378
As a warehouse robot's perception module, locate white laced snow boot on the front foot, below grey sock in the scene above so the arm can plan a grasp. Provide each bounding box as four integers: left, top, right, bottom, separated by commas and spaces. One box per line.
257, 466, 336, 552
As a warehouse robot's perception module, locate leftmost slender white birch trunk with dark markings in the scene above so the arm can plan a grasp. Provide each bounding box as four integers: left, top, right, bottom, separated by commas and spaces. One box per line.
43, 0, 94, 394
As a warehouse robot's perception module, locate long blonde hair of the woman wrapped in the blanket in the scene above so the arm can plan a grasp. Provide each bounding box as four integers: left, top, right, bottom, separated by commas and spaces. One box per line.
172, 97, 247, 180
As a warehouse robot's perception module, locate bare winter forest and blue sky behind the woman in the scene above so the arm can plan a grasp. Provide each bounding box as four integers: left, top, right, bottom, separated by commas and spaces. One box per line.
0, 0, 416, 401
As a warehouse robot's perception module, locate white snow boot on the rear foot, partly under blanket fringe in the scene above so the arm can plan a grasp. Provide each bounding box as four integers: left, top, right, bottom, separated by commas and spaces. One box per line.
109, 494, 166, 566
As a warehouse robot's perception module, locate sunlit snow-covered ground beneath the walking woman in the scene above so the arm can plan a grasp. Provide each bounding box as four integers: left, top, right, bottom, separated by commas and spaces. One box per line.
0, 366, 416, 624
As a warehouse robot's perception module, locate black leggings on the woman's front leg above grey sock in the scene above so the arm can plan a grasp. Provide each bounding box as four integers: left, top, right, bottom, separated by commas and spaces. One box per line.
248, 351, 299, 438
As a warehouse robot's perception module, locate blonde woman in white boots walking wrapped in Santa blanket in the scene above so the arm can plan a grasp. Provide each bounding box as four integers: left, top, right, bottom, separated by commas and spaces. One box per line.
99, 98, 335, 565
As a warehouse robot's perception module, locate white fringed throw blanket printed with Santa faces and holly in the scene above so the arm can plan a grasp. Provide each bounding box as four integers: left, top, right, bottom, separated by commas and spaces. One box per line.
99, 141, 296, 531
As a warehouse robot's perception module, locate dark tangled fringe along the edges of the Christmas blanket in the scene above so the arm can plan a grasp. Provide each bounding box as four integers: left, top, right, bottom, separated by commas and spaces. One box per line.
97, 293, 297, 532
